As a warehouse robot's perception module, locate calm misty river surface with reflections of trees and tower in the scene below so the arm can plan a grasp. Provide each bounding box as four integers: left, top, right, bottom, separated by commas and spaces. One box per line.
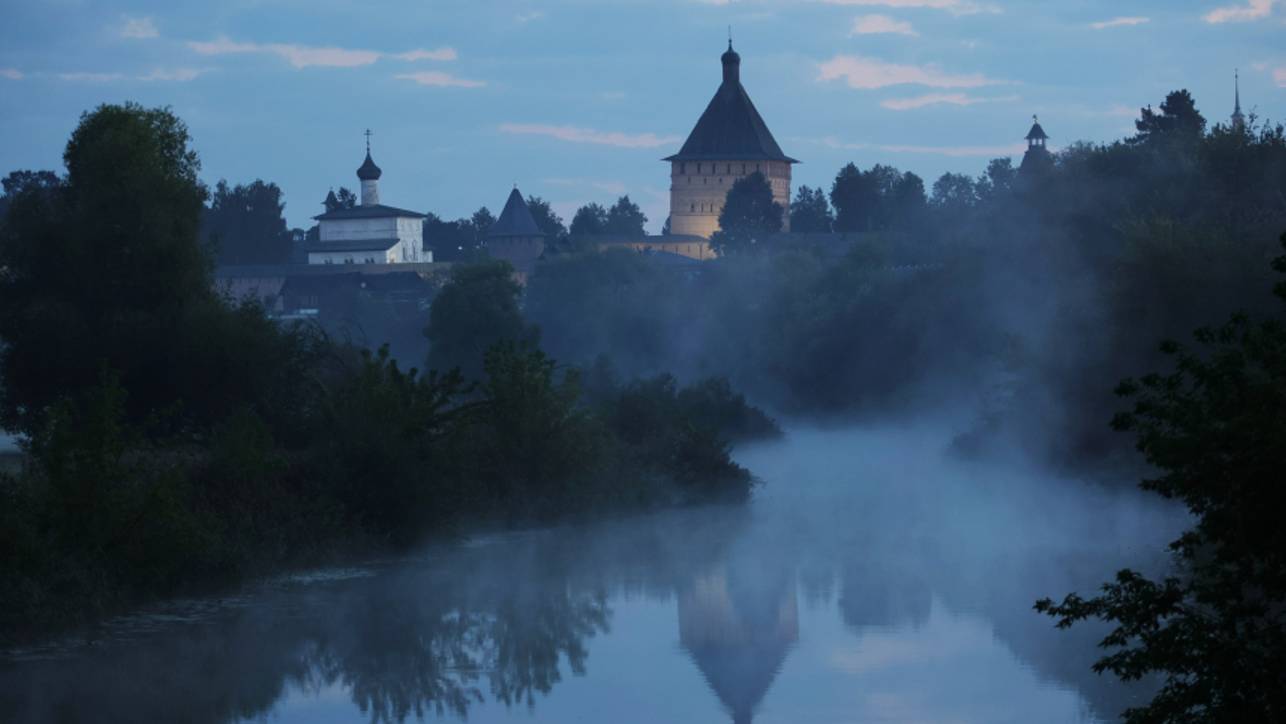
0, 427, 1177, 724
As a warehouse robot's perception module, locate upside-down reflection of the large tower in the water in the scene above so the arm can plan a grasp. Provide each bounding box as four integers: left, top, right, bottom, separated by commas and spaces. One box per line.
679, 566, 799, 724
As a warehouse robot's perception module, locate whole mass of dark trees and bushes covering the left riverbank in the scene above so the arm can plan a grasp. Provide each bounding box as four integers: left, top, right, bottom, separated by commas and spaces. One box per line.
0, 104, 778, 642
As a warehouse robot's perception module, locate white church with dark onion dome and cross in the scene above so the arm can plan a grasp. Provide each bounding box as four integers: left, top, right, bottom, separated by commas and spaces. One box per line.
307, 131, 433, 264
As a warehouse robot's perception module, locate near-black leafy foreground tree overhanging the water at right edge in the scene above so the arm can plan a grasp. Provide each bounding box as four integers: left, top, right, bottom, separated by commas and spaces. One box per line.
1037, 234, 1286, 724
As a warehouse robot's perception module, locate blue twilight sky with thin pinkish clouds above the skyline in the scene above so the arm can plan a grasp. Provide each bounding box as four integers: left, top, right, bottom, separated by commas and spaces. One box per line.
0, 0, 1286, 230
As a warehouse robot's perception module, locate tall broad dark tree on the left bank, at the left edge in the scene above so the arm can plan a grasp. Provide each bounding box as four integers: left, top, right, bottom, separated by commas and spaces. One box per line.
0, 103, 316, 430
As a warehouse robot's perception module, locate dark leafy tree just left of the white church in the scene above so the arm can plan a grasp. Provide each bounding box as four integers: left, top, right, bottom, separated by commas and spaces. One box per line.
203, 180, 291, 265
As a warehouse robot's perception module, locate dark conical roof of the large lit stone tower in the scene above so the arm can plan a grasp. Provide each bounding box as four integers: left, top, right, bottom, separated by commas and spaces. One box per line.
665, 42, 799, 163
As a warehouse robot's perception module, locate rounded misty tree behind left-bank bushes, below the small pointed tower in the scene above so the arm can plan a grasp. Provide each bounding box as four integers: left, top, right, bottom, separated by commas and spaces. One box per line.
424, 260, 536, 379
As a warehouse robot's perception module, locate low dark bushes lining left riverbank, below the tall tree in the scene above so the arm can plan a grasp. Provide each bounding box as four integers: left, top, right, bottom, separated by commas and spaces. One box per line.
0, 357, 778, 643
